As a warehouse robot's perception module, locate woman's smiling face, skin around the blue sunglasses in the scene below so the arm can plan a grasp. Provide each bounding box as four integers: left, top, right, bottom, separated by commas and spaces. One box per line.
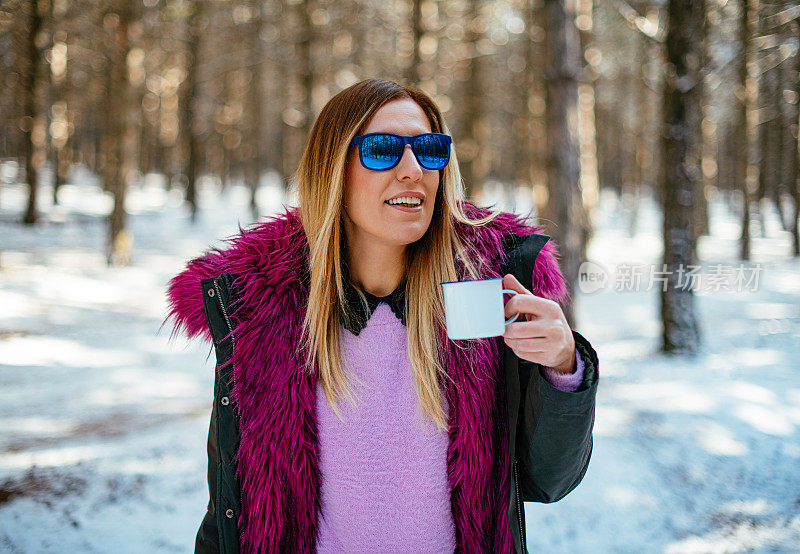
344, 99, 439, 252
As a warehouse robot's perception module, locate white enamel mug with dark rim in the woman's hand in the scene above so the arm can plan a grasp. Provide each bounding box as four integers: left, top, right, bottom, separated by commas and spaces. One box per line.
441, 277, 519, 340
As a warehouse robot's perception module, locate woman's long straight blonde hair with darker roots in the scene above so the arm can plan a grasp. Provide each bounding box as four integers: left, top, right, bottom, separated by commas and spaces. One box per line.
291, 79, 501, 429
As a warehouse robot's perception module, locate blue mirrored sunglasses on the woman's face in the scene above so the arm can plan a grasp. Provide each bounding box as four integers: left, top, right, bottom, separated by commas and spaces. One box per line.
350, 133, 453, 171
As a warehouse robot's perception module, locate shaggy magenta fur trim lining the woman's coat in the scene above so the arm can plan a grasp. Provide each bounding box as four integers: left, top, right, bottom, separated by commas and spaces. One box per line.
164, 202, 569, 552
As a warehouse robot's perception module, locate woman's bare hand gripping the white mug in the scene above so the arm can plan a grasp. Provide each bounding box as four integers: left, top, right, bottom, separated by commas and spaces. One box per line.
503, 273, 576, 373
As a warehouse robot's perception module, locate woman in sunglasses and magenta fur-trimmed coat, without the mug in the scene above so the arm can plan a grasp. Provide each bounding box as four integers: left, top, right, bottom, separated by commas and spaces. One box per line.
165, 79, 599, 553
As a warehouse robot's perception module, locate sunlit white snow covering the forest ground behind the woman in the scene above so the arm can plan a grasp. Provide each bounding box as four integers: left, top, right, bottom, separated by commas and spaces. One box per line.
0, 166, 800, 553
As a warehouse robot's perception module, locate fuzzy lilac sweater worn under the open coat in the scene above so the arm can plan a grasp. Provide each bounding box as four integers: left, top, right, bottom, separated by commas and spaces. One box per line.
316, 303, 584, 553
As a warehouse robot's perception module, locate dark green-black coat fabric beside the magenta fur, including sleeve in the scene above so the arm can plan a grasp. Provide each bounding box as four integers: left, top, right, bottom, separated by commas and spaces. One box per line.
195, 231, 599, 554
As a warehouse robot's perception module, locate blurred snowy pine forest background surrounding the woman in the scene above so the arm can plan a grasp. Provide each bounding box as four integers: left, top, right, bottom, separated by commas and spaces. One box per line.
0, 0, 800, 552
